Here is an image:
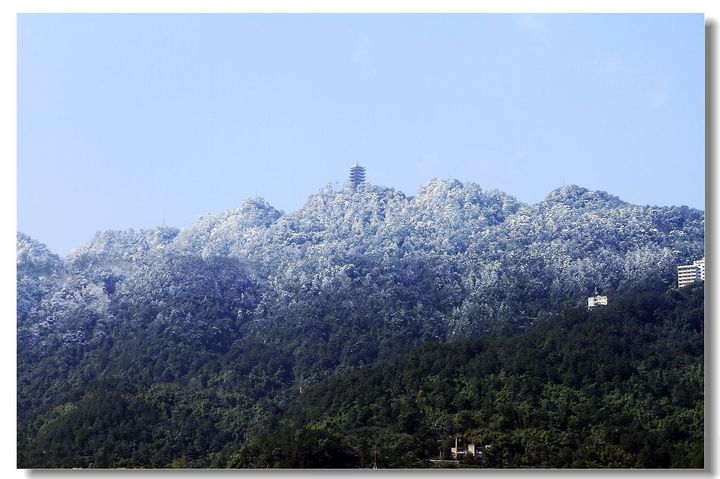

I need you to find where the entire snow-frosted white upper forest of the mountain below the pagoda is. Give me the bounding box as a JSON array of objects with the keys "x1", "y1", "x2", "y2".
[{"x1": 18, "y1": 179, "x2": 704, "y2": 350}]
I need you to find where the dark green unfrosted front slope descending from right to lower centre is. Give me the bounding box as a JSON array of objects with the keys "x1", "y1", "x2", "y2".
[{"x1": 235, "y1": 286, "x2": 704, "y2": 468}]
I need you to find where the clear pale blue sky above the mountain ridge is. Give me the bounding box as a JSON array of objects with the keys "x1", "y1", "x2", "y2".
[{"x1": 18, "y1": 14, "x2": 705, "y2": 255}]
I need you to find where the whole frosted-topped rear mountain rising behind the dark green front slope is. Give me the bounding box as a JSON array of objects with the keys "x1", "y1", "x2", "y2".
[{"x1": 17, "y1": 180, "x2": 704, "y2": 467}]
